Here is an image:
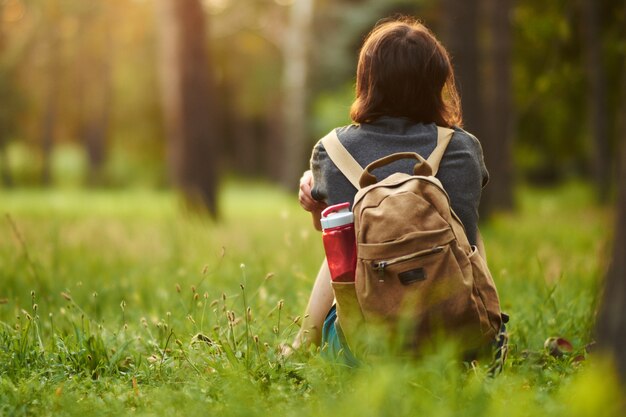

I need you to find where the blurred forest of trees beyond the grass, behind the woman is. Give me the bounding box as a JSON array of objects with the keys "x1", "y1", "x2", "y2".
[{"x1": 0, "y1": 0, "x2": 625, "y2": 205}]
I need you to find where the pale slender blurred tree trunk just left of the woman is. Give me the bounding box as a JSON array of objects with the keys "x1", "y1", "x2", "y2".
[{"x1": 281, "y1": 0, "x2": 313, "y2": 189}]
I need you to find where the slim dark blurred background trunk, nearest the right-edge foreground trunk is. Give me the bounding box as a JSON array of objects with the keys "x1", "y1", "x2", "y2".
[{"x1": 582, "y1": 0, "x2": 611, "y2": 202}]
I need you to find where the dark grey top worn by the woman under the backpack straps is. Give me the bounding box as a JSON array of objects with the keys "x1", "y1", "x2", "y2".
[{"x1": 311, "y1": 116, "x2": 489, "y2": 245}]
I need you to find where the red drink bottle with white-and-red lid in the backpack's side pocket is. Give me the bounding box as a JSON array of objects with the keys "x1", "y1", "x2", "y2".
[{"x1": 321, "y1": 203, "x2": 356, "y2": 282}]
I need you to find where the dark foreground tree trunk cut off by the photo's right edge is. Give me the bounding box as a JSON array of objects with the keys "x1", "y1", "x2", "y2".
[{"x1": 596, "y1": 52, "x2": 626, "y2": 386}]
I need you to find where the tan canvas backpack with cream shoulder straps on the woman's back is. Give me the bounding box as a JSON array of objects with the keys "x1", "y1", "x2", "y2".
[{"x1": 322, "y1": 128, "x2": 502, "y2": 352}]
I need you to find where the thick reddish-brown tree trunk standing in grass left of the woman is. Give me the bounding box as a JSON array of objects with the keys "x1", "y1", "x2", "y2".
[{"x1": 158, "y1": 0, "x2": 218, "y2": 215}]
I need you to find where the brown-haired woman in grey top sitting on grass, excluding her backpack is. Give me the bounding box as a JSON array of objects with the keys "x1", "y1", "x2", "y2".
[{"x1": 293, "y1": 18, "x2": 488, "y2": 358}]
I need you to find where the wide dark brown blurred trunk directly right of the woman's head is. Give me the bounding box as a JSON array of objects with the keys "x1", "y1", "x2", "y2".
[{"x1": 442, "y1": 0, "x2": 514, "y2": 218}]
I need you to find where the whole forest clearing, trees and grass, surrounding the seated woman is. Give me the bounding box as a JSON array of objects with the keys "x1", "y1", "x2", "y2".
[{"x1": 0, "y1": 0, "x2": 626, "y2": 415}]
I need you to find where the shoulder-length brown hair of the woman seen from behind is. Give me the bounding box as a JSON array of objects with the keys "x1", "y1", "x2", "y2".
[{"x1": 350, "y1": 18, "x2": 462, "y2": 127}]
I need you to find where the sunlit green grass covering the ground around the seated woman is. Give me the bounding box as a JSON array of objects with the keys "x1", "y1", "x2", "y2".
[{"x1": 0, "y1": 183, "x2": 624, "y2": 416}]
